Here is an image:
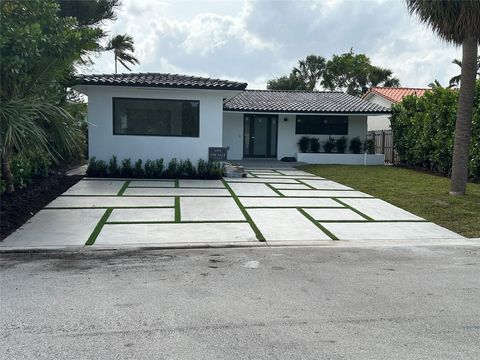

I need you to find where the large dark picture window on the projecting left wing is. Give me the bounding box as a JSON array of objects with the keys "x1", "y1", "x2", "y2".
[{"x1": 113, "y1": 98, "x2": 200, "y2": 137}]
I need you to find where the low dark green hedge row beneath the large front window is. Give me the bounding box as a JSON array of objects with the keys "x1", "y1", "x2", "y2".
[{"x1": 87, "y1": 156, "x2": 223, "y2": 179}]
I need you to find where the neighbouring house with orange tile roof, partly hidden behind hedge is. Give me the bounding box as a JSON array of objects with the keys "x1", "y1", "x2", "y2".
[{"x1": 362, "y1": 87, "x2": 428, "y2": 131}]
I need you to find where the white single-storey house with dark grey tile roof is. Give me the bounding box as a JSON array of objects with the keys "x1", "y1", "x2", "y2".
[{"x1": 74, "y1": 73, "x2": 390, "y2": 162}]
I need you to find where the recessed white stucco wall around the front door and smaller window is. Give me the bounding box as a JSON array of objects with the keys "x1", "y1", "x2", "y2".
[{"x1": 223, "y1": 112, "x2": 367, "y2": 160}]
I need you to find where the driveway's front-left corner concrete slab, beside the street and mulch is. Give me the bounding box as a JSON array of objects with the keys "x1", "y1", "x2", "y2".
[{"x1": 0, "y1": 209, "x2": 105, "y2": 247}]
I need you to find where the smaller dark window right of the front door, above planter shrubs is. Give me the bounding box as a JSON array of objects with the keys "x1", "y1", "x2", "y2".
[{"x1": 295, "y1": 115, "x2": 348, "y2": 135}]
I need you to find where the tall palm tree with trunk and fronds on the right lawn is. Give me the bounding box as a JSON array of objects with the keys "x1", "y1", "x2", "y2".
[{"x1": 406, "y1": 0, "x2": 480, "y2": 195}]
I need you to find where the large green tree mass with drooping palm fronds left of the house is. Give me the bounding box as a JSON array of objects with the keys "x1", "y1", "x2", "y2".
[{"x1": 0, "y1": 0, "x2": 109, "y2": 192}]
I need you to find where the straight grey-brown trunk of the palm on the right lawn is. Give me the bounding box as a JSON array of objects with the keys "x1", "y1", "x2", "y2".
[{"x1": 450, "y1": 38, "x2": 478, "y2": 195}]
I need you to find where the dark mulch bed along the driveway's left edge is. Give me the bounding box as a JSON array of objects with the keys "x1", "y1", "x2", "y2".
[{"x1": 0, "y1": 174, "x2": 83, "y2": 240}]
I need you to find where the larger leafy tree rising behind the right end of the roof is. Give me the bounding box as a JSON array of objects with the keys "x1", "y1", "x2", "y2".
[{"x1": 322, "y1": 49, "x2": 400, "y2": 96}]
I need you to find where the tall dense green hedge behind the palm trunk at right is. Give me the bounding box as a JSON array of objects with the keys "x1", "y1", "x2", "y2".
[{"x1": 391, "y1": 81, "x2": 480, "y2": 181}]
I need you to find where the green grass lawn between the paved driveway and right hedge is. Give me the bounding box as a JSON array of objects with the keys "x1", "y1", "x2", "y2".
[{"x1": 300, "y1": 165, "x2": 480, "y2": 237}]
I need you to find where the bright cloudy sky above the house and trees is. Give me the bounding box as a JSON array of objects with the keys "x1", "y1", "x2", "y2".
[{"x1": 82, "y1": 0, "x2": 461, "y2": 89}]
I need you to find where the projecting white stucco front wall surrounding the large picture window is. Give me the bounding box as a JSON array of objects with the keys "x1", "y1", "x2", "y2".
[{"x1": 88, "y1": 86, "x2": 230, "y2": 164}]
